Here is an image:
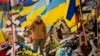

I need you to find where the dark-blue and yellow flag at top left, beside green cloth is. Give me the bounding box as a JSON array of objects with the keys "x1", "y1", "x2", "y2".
[{"x1": 17, "y1": 0, "x2": 38, "y2": 16}]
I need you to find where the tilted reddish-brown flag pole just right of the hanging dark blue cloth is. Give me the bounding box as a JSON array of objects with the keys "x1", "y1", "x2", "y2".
[{"x1": 79, "y1": 0, "x2": 87, "y2": 56}]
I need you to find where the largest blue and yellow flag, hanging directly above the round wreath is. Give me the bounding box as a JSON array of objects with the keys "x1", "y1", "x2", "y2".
[{"x1": 41, "y1": 0, "x2": 75, "y2": 27}]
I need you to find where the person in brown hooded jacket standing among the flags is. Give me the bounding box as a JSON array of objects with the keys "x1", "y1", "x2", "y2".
[{"x1": 26, "y1": 15, "x2": 47, "y2": 55}]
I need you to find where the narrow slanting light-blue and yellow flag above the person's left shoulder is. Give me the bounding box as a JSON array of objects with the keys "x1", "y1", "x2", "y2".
[{"x1": 21, "y1": 0, "x2": 46, "y2": 27}]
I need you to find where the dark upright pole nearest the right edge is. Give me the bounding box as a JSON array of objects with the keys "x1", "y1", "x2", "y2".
[{"x1": 92, "y1": 1, "x2": 98, "y2": 46}]
